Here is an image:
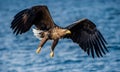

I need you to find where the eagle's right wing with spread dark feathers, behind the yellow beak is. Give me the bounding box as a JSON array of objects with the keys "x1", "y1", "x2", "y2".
[{"x1": 66, "y1": 19, "x2": 108, "y2": 58}]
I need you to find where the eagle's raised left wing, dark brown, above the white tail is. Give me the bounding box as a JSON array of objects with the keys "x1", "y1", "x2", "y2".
[{"x1": 11, "y1": 6, "x2": 54, "y2": 35}]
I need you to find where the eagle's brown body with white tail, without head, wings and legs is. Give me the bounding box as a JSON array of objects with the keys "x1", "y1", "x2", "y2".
[{"x1": 33, "y1": 27, "x2": 65, "y2": 40}]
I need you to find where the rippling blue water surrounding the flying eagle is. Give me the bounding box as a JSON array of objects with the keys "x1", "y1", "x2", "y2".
[{"x1": 0, "y1": 0, "x2": 120, "y2": 72}]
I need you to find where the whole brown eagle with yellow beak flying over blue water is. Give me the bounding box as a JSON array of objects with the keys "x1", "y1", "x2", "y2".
[{"x1": 10, "y1": 5, "x2": 108, "y2": 58}]
